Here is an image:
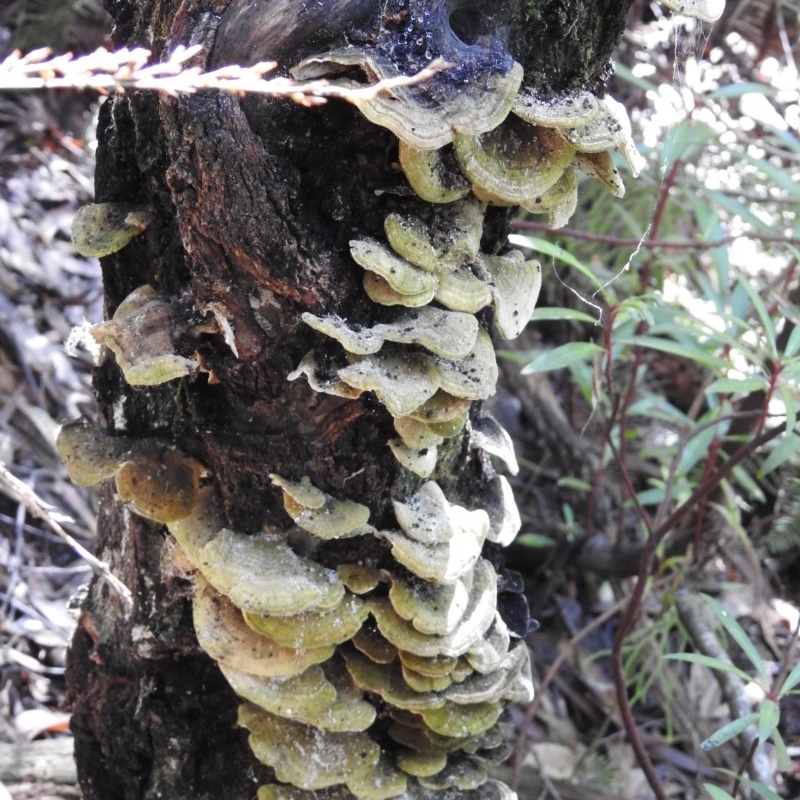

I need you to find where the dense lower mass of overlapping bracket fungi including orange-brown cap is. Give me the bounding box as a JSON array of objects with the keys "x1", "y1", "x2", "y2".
[{"x1": 57, "y1": 423, "x2": 532, "y2": 800}]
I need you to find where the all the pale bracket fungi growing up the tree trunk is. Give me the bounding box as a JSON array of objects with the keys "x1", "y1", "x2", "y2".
[{"x1": 62, "y1": 0, "x2": 720, "y2": 800}]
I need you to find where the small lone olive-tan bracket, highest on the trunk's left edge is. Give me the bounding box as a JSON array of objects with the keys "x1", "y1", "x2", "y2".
[{"x1": 72, "y1": 203, "x2": 154, "y2": 258}]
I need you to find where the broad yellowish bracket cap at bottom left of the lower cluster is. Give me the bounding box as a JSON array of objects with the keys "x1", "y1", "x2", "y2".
[{"x1": 239, "y1": 704, "x2": 380, "y2": 791}]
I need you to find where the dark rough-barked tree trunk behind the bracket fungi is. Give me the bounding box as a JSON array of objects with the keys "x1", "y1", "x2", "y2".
[{"x1": 68, "y1": 0, "x2": 629, "y2": 800}]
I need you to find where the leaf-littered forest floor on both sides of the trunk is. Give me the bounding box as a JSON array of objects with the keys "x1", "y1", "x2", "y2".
[{"x1": 0, "y1": 7, "x2": 800, "y2": 800}]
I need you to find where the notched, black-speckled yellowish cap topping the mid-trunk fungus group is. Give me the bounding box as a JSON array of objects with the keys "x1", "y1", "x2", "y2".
[{"x1": 384, "y1": 197, "x2": 483, "y2": 273}]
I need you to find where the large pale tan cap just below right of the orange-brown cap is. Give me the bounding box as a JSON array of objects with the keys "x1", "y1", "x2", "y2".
[{"x1": 198, "y1": 528, "x2": 344, "y2": 616}]
